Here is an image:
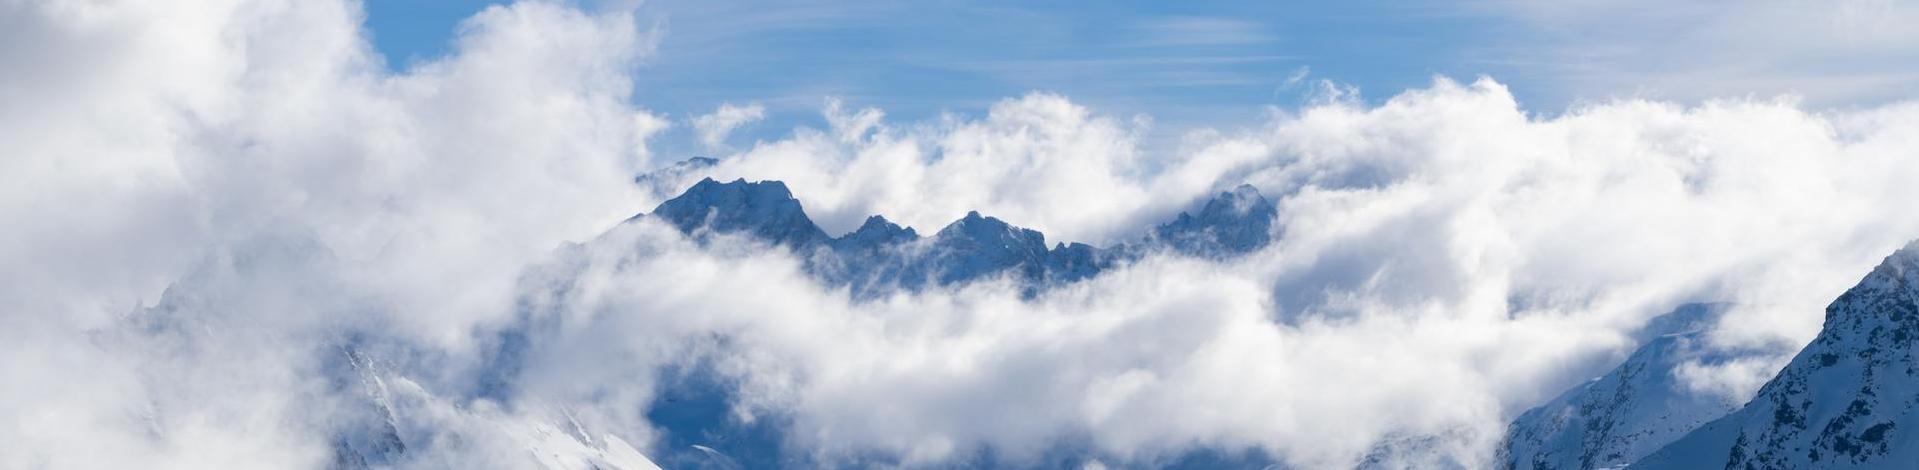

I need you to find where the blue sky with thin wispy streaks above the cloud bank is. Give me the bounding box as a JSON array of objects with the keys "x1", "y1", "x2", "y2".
[{"x1": 367, "y1": 0, "x2": 1919, "y2": 155}]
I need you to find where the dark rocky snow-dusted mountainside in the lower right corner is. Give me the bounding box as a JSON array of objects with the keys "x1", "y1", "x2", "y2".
[{"x1": 1633, "y1": 242, "x2": 1919, "y2": 468}]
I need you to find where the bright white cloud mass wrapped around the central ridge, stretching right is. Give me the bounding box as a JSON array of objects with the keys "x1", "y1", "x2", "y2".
[{"x1": 525, "y1": 81, "x2": 1919, "y2": 468}]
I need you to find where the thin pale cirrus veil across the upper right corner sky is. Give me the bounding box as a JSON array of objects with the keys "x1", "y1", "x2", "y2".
[{"x1": 1472, "y1": 0, "x2": 1919, "y2": 107}]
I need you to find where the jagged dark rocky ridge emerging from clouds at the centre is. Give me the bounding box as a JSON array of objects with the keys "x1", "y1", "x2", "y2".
[{"x1": 633, "y1": 178, "x2": 1278, "y2": 297}]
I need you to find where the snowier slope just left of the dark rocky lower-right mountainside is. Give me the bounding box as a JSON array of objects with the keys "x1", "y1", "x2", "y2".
[{"x1": 1499, "y1": 303, "x2": 1764, "y2": 470}]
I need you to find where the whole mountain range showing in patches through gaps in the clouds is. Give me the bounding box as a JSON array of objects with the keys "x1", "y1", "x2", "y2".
[{"x1": 131, "y1": 161, "x2": 1919, "y2": 468}]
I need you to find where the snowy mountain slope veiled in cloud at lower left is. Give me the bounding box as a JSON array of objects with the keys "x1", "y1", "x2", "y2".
[{"x1": 110, "y1": 232, "x2": 660, "y2": 470}]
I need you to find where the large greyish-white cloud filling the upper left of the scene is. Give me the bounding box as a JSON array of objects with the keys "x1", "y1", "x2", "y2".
[{"x1": 0, "y1": 2, "x2": 649, "y2": 468}]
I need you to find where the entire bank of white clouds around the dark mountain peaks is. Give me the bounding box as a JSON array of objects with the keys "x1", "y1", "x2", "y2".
[{"x1": 0, "y1": 2, "x2": 1919, "y2": 468}]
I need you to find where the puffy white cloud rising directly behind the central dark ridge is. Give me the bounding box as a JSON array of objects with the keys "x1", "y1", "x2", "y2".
[{"x1": 690, "y1": 94, "x2": 1166, "y2": 240}]
